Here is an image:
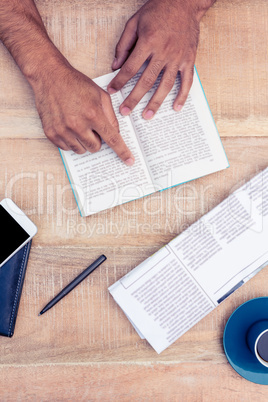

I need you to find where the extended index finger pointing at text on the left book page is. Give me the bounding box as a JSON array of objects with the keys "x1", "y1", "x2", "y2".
[{"x1": 94, "y1": 114, "x2": 135, "y2": 166}]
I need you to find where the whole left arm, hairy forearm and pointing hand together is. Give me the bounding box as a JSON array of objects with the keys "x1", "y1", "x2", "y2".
[{"x1": 0, "y1": 0, "x2": 134, "y2": 165}]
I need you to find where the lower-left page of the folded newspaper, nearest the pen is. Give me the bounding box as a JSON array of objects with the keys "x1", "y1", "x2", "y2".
[{"x1": 109, "y1": 247, "x2": 214, "y2": 353}]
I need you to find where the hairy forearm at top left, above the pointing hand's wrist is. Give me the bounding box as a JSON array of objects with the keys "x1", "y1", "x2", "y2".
[{"x1": 0, "y1": 0, "x2": 66, "y2": 83}]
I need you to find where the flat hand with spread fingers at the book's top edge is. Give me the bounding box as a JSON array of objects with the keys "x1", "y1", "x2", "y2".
[{"x1": 108, "y1": 0, "x2": 215, "y2": 119}]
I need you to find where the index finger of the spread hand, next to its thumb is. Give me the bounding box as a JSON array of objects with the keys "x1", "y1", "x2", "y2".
[{"x1": 107, "y1": 40, "x2": 151, "y2": 94}]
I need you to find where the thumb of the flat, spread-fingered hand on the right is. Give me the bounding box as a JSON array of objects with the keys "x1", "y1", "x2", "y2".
[{"x1": 112, "y1": 18, "x2": 138, "y2": 70}]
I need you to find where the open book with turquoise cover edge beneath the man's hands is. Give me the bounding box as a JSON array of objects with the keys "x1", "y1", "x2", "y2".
[{"x1": 60, "y1": 67, "x2": 229, "y2": 216}]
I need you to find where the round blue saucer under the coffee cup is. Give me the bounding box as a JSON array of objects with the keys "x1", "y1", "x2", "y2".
[{"x1": 223, "y1": 297, "x2": 268, "y2": 385}]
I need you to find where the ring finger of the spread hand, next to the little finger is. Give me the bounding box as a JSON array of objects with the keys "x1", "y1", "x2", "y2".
[{"x1": 142, "y1": 67, "x2": 178, "y2": 120}]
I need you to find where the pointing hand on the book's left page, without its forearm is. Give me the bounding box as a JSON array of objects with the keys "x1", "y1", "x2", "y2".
[{"x1": 31, "y1": 62, "x2": 134, "y2": 165}]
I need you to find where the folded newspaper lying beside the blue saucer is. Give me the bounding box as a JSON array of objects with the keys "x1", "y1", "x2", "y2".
[{"x1": 109, "y1": 168, "x2": 268, "y2": 353}]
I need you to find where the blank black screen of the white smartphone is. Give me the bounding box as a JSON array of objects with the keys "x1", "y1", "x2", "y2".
[{"x1": 0, "y1": 205, "x2": 30, "y2": 264}]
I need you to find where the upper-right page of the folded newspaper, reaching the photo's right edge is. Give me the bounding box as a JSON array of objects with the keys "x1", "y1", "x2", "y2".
[{"x1": 169, "y1": 169, "x2": 268, "y2": 304}]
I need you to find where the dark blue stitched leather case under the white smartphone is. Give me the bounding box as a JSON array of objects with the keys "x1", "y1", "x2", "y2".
[{"x1": 0, "y1": 240, "x2": 32, "y2": 338}]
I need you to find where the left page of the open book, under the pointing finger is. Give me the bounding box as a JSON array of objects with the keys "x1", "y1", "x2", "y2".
[{"x1": 61, "y1": 73, "x2": 154, "y2": 216}]
